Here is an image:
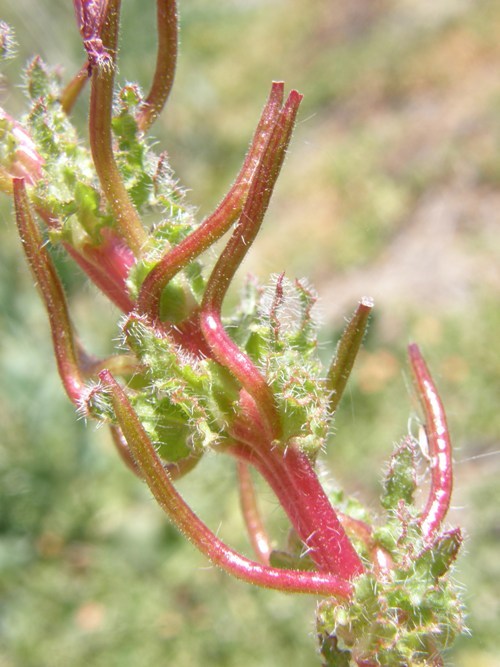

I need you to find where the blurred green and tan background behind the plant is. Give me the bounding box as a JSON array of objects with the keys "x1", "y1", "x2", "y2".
[{"x1": 0, "y1": 0, "x2": 500, "y2": 667}]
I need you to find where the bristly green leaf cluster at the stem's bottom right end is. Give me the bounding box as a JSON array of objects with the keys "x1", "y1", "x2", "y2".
[{"x1": 318, "y1": 430, "x2": 464, "y2": 667}]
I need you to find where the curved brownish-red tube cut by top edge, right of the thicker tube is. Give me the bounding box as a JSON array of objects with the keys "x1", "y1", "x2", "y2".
[{"x1": 136, "y1": 0, "x2": 178, "y2": 132}]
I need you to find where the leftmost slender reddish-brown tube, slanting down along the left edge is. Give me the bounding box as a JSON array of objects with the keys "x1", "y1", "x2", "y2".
[{"x1": 13, "y1": 178, "x2": 85, "y2": 405}]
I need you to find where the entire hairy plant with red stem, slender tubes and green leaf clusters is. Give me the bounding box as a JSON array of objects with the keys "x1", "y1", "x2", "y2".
[{"x1": 0, "y1": 0, "x2": 463, "y2": 666}]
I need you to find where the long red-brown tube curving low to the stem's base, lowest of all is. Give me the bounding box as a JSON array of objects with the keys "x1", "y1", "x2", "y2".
[{"x1": 100, "y1": 371, "x2": 352, "y2": 599}]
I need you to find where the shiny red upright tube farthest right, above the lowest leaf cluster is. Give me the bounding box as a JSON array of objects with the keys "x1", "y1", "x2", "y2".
[{"x1": 408, "y1": 343, "x2": 453, "y2": 539}]
